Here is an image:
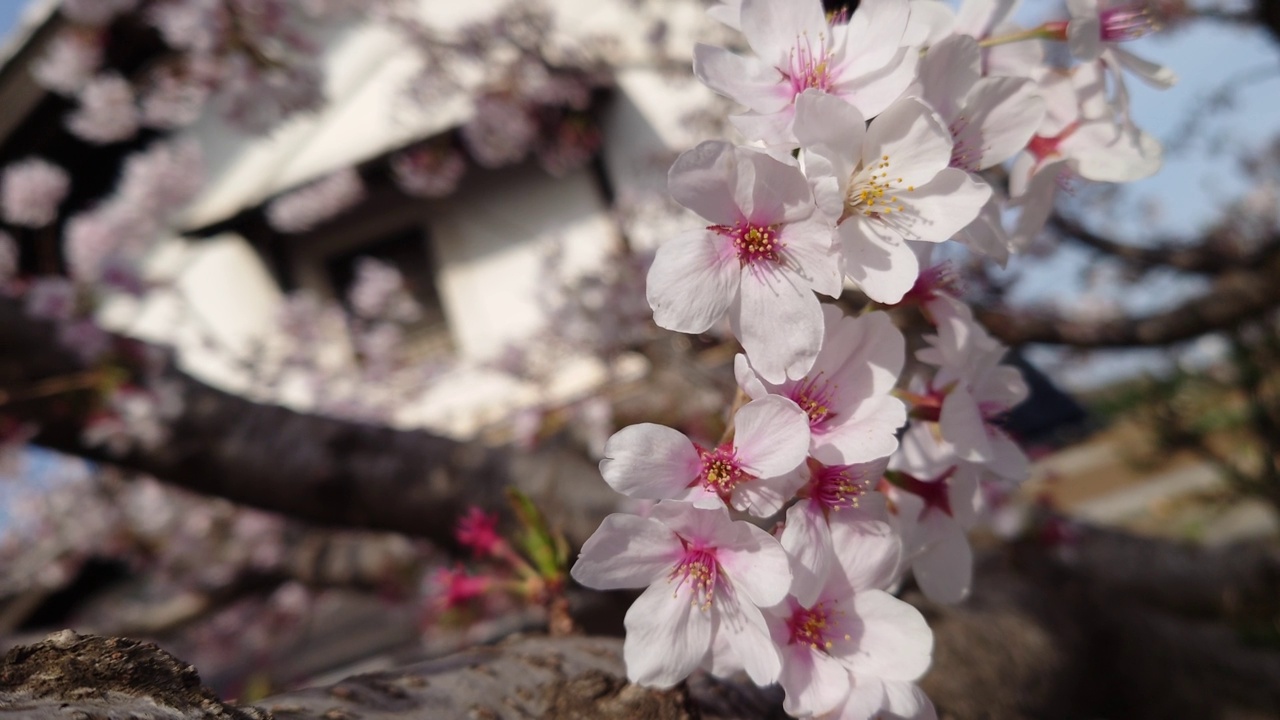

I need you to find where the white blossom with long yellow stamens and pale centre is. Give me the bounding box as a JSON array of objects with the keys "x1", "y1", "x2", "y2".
[{"x1": 795, "y1": 91, "x2": 991, "y2": 304}]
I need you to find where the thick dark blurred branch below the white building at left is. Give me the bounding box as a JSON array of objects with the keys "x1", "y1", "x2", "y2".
[{"x1": 0, "y1": 299, "x2": 616, "y2": 547}]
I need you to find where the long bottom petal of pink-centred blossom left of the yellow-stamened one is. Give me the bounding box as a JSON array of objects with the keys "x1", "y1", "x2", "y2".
[{"x1": 732, "y1": 266, "x2": 822, "y2": 383}]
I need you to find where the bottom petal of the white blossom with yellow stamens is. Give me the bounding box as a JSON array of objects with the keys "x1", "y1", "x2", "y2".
[{"x1": 836, "y1": 215, "x2": 920, "y2": 305}]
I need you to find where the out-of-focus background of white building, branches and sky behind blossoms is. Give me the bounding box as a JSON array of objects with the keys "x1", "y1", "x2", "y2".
[{"x1": 0, "y1": 0, "x2": 1280, "y2": 719}]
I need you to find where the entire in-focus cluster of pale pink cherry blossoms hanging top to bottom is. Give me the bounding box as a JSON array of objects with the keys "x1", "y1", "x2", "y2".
[{"x1": 572, "y1": 0, "x2": 1172, "y2": 719}]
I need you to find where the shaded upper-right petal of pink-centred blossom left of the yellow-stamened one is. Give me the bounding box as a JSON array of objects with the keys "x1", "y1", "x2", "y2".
[{"x1": 733, "y1": 147, "x2": 814, "y2": 222}]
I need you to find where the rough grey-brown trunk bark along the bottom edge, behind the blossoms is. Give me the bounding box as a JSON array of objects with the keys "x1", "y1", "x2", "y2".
[{"x1": 0, "y1": 529, "x2": 1280, "y2": 720}]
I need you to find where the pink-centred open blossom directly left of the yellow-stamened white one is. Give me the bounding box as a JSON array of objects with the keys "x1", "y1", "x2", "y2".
[{"x1": 646, "y1": 136, "x2": 855, "y2": 382}]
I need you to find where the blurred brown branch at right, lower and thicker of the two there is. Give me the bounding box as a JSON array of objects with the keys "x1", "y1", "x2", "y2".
[{"x1": 974, "y1": 258, "x2": 1280, "y2": 347}]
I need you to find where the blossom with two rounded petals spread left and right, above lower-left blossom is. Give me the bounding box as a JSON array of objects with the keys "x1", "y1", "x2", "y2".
[{"x1": 600, "y1": 395, "x2": 809, "y2": 518}]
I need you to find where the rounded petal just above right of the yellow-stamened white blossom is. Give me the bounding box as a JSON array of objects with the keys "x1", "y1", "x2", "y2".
[{"x1": 956, "y1": 77, "x2": 1044, "y2": 170}]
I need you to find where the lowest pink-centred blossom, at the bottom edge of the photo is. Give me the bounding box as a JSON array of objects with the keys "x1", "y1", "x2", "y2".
[{"x1": 765, "y1": 520, "x2": 933, "y2": 716}]
